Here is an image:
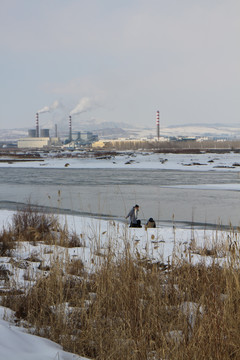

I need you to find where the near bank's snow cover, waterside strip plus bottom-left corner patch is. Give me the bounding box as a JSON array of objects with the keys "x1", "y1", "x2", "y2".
[{"x1": 0, "y1": 211, "x2": 238, "y2": 360}]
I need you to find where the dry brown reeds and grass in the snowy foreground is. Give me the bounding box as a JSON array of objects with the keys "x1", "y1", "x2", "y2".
[{"x1": 0, "y1": 209, "x2": 240, "y2": 360}]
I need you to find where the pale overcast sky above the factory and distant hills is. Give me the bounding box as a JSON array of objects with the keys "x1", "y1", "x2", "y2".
[{"x1": 0, "y1": 0, "x2": 240, "y2": 129}]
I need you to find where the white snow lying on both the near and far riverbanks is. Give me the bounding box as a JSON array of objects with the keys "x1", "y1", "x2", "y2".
[{"x1": 0, "y1": 153, "x2": 240, "y2": 360}]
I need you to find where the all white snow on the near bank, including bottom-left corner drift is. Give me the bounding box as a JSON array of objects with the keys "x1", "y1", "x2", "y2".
[{"x1": 0, "y1": 210, "x2": 234, "y2": 360}]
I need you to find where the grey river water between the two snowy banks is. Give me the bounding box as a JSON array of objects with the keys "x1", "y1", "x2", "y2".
[{"x1": 0, "y1": 167, "x2": 240, "y2": 227}]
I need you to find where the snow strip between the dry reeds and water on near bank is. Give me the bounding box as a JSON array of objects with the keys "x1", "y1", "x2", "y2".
[{"x1": 0, "y1": 210, "x2": 234, "y2": 290}]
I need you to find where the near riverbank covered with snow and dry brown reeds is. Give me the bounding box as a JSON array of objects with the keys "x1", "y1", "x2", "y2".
[{"x1": 0, "y1": 208, "x2": 240, "y2": 360}]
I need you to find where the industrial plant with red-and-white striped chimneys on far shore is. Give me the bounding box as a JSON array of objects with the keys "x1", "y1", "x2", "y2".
[{"x1": 0, "y1": 110, "x2": 240, "y2": 152}]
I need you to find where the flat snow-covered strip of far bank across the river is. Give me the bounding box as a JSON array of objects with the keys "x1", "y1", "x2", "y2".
[{"x1": 0, "y1": 152, "x2": 240, "y2": 171}]
